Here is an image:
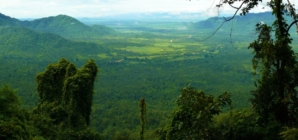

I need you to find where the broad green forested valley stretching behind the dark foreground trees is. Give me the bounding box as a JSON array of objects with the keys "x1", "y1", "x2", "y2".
[{"x1": 0, "y1": 11, "x2": 252, "y2": 137}]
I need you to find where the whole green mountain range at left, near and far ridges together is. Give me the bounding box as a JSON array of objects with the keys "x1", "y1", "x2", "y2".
[{"x1": 0, "y1": 14, "x2": 109, "y2": 60}]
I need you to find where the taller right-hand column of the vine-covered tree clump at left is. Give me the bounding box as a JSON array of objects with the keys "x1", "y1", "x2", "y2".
[{"x1": 62, "y1": 60, "x2": 98, "y2": 126}]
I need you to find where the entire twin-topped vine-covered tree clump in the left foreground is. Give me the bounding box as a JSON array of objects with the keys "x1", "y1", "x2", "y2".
[{"x1": 31, "y1": 59, "x2": 100, "y2": 139}]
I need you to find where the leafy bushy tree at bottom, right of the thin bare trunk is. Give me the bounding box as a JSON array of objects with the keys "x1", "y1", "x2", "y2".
[{"x1": 160, "y1": 86, "x2": 232, "y2": 140}]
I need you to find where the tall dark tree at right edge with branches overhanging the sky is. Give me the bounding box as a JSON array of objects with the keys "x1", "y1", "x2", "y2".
[{"x1": 217, "y1": 0, "x2": 298, "y2": 126}]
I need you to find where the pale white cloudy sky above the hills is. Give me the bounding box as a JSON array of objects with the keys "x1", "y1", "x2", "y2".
[{"x1": 0, "y1": 0, "x2": 298, "y2": 18}]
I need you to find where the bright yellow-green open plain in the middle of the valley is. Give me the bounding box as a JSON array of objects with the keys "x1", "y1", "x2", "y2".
[{"x1": 92, "y1": 22, "x2": 256, "y2": 61}]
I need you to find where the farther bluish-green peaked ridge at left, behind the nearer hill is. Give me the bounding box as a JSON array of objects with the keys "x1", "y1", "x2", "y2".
[{"x1": 0, "y1": 14, "x2": 115, "y2": 39}]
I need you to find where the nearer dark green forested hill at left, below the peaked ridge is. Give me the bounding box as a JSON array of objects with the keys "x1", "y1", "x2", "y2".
[{"x1": 0, "y1": 26, "x2": 104, "y2": 59}]
